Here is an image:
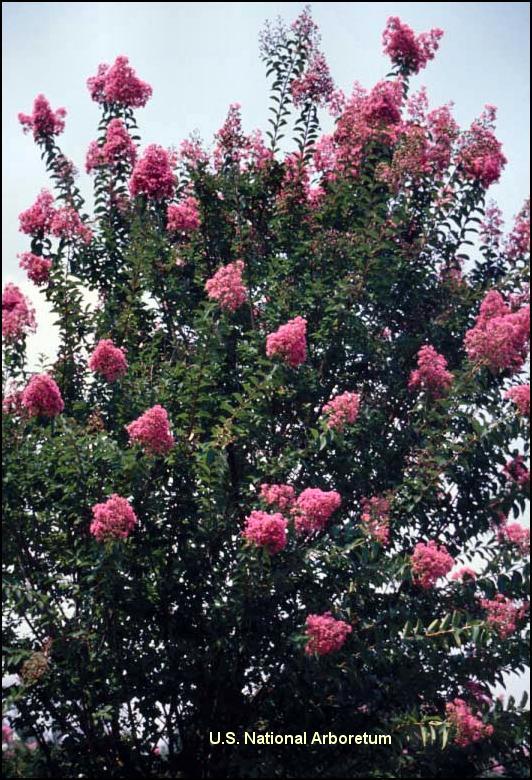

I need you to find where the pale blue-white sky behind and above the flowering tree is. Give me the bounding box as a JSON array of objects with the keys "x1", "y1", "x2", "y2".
[{"x1": 2, "y1": 2, "x2": 530, "y2": 691}]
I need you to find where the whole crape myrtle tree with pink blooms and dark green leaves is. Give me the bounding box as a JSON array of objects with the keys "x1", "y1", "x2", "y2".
[{"x1": 2, "y1": 9, "x2": 530, "y2": 777}]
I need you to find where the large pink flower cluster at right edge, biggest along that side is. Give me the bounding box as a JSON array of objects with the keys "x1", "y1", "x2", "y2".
[{"x1": 464, "y1": 290, "x2": 530, "y2": 373}]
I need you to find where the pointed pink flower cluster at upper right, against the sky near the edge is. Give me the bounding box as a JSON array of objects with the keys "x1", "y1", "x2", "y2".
[{"x1": 456, "y1": 106, "x2": 507, "y2": 189}]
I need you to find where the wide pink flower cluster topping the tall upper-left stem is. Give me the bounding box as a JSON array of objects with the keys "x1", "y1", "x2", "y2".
[{"x1": 87, "y1": 56, "x2": 152, "y2": 108}]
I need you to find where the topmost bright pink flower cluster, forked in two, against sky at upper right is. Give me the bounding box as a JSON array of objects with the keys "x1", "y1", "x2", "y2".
[{"x1": 382, "y1": 16, "x2": 443, "y2": 75}]
